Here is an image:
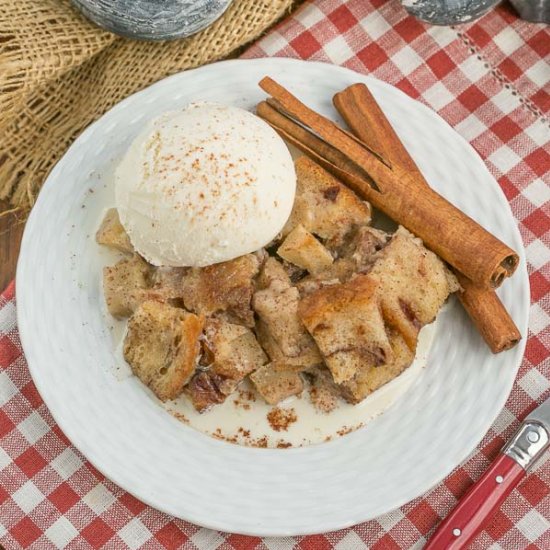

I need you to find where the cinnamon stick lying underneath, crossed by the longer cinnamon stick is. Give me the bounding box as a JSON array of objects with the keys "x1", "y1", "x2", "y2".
[{"x1": 333, "y1": 84, "x2": 521, "y2": 353}]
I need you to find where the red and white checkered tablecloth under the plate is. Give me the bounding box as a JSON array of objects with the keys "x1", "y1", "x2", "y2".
[{"x1": 0, "y1": 0, "x2": 550, "y2": 550}]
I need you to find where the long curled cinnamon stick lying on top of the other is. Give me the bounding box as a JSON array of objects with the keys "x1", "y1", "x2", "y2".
[{"x1": 260, "y1": 77, "x2": 518, "y2": 294}]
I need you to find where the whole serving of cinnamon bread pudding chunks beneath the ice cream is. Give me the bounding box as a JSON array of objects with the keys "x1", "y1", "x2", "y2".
[{"x1": 96, "y1": 157, "x2": 459, "y2": 422}]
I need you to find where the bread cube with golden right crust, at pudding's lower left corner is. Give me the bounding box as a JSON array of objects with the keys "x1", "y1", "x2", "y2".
[{"x1": 124, "y1": 300, "x2": 204, "y2": 401}]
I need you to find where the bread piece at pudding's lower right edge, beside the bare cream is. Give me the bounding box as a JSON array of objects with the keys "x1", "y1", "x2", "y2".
[{"x1": 341, "y1": 330, "x2": 414, "y2": 404}]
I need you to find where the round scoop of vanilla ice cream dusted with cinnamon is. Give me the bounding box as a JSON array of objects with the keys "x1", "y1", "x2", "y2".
[{"x1": 115, "y1": 103, "x2": 296, "y2": 267}]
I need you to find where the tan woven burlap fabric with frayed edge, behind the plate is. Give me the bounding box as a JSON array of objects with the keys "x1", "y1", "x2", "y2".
[{"x1": 0, "y1": 0, "x2": 293, "y2": 209}]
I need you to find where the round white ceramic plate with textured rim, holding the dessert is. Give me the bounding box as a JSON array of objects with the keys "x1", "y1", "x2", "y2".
[{"x1": 17, "y1": 59, "x2": 529, "y2": 536}]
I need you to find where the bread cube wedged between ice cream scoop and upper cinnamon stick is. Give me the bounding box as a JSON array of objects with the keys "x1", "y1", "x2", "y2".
[{"x1": 283, "y1": 156, "x2": 371, "y2": 246}]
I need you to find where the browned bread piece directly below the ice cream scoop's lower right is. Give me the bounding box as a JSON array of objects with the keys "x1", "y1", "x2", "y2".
[{"x1": 183, "y1": 254, "x2": 260, "y2": 327}]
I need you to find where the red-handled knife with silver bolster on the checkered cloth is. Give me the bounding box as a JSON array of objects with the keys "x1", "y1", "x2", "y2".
[{"x1": 424, "y1": 398, "x2": 550, "y2": 550}]
